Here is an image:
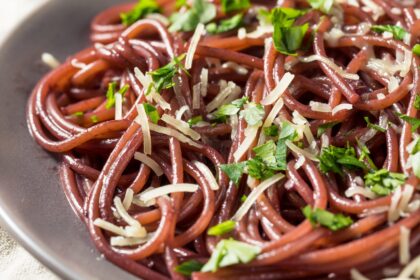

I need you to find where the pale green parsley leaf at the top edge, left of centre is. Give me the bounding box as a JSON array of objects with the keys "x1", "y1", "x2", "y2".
[{"x1": 169, "y1": 0, "x2": 216, "y2": 32}]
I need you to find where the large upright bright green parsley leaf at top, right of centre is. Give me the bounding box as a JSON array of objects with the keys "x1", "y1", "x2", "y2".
[{"x1": 271, "y1": 8, "x2": 309, "y2": 55}]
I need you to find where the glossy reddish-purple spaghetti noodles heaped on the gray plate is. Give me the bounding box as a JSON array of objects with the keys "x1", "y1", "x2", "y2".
[{"x1": 27, "y1": 0, "x2": 420, "y2": 279}]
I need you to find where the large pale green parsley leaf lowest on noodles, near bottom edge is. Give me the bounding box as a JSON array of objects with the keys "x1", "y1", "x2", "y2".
[{"x1": 201, "y1": 238, "x2": 261, "y2": 272}]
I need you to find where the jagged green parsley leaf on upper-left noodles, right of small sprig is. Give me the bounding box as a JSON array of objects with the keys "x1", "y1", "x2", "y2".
[{"x1": 147, "y1": 54, "x2": 189, "y2": 93}]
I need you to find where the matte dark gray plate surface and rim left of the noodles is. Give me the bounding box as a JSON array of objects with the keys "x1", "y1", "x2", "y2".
[{"x1": 0, "y1": 0, "x2": 135, "y2": 279}]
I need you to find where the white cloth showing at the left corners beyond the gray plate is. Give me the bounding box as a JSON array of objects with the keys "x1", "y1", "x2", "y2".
[{"x1": 0, "y1": 0, "x2": 58, "y2": 280}]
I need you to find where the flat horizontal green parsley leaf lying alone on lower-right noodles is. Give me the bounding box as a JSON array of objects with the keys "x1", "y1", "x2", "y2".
[{"x1": 302, "y1": 205, "x2": 353, "y2": 231}]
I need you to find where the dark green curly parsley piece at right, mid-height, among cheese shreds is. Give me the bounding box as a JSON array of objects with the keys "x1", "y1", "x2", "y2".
[{"x1": 319, "y1": 145, "x2": 367, "y2": 175}]
